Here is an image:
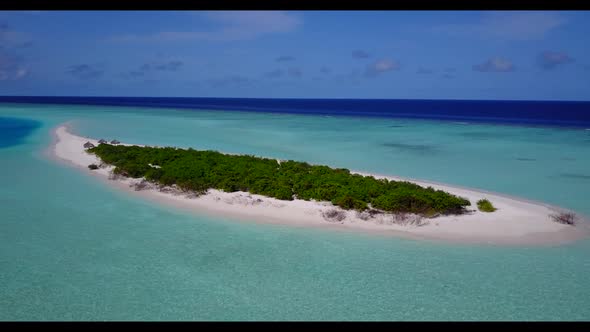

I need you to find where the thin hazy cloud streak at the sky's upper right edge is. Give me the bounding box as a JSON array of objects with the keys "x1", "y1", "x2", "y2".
[{"x1": 434, "y1": 11, "x2": 567, "y2": 40}]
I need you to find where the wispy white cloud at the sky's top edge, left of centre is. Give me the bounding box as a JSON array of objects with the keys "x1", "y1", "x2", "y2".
[{"x1": 111, "y1": 11, "x2": 303, "y2": 41}]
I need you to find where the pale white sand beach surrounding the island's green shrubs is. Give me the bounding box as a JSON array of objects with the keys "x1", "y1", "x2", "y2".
[{"x1": 51, "y1": 125, "x2": 588, "y2": 245}]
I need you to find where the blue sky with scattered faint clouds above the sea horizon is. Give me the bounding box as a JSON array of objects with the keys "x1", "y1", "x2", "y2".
[{"x1": 0, "y1": 11, "x2": 590, "y2": 100}]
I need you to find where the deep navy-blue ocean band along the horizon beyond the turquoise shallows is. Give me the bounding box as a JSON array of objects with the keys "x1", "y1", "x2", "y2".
[{"x1": 0, "y1": 96, "x2": 590, "y2": 128}]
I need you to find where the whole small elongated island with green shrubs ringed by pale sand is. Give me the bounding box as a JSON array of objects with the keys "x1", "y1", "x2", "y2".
[{"x1": 52, "y1": 125, "x2": 586, "y2": 244}]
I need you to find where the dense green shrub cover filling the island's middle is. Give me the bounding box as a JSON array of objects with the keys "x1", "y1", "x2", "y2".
[{"x1": 88, "y1": 144, "x2": 470, "y2": 216}]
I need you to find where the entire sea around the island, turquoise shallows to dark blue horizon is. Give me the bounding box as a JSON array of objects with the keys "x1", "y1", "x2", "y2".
[{"x1": 0, "y1": 97, "x2": 590, "y2": 320}]
